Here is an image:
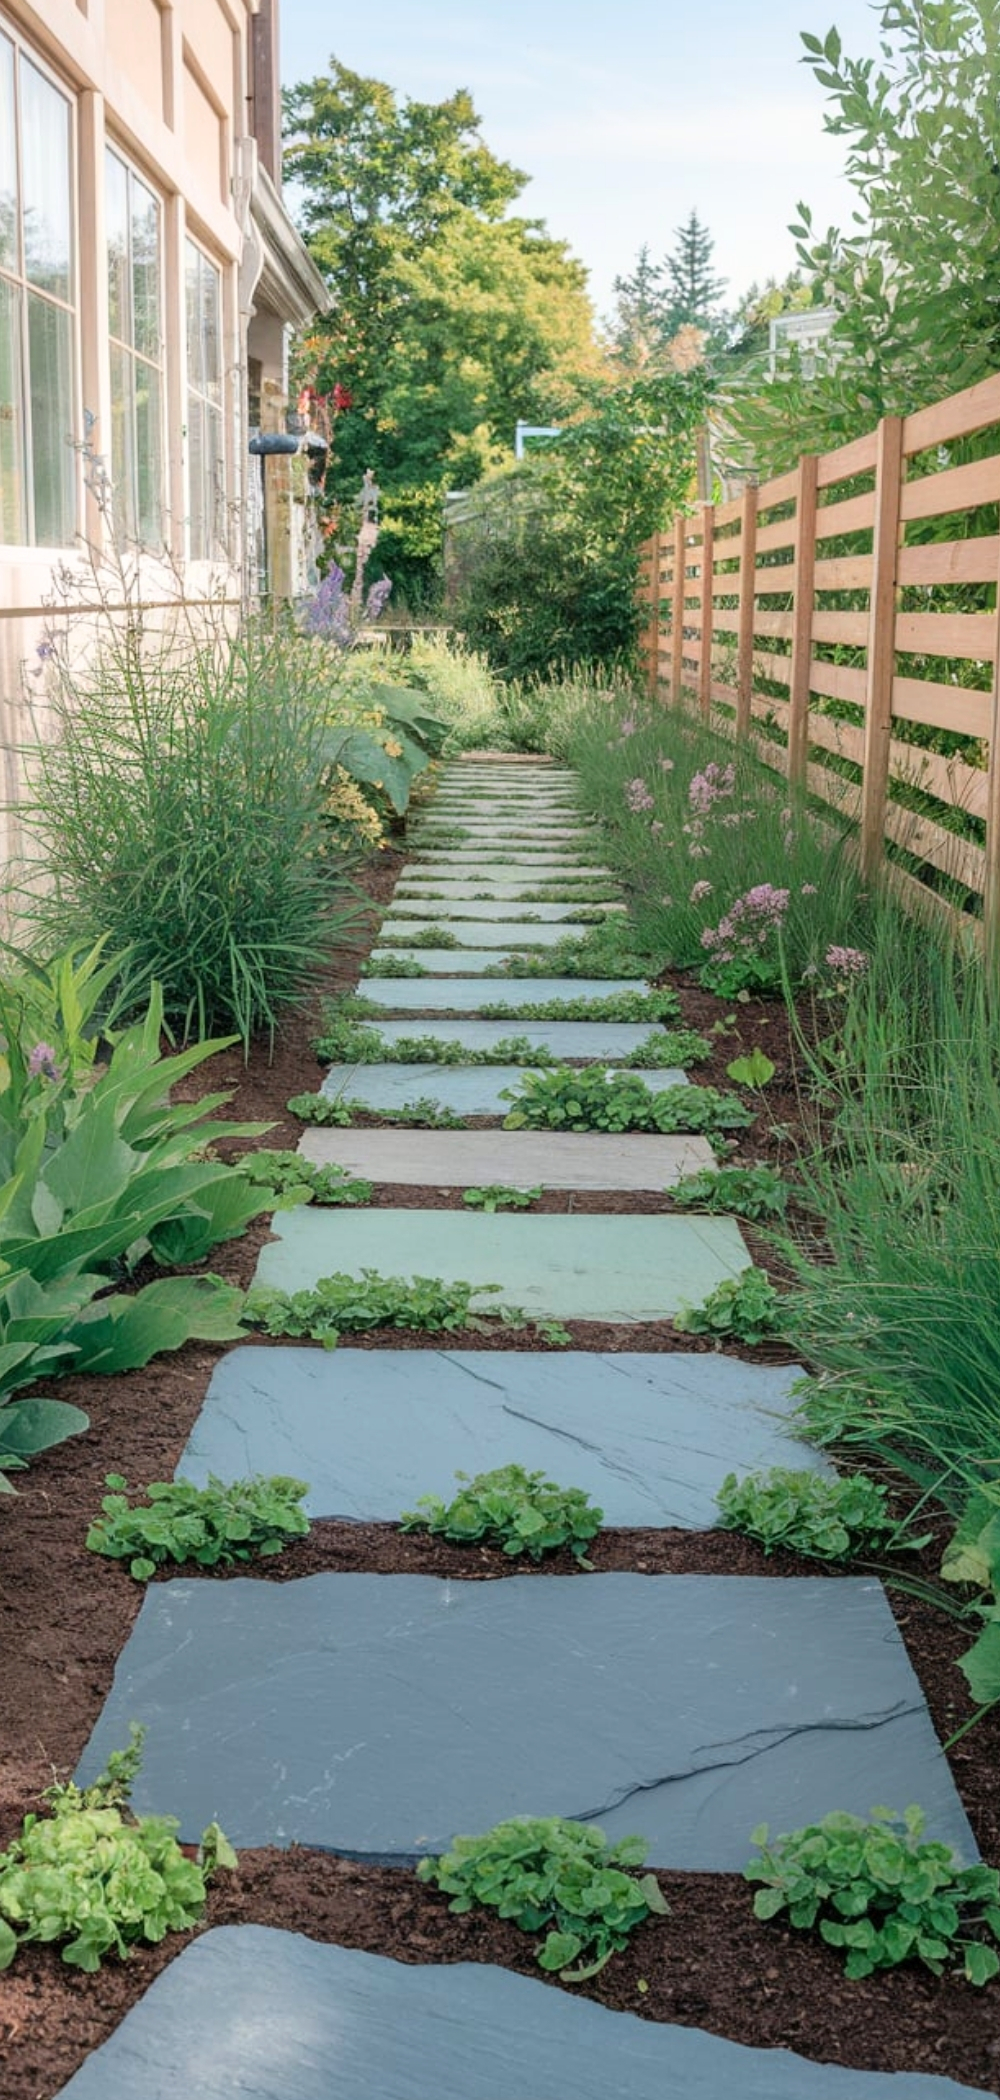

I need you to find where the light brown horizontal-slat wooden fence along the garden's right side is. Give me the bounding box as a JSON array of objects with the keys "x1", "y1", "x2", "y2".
[{"x1": 641, "y1": 374, "x2": 1000, "y2": 960}]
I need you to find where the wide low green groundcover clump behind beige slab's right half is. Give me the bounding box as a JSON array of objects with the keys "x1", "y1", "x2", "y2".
[{"x1": 504, "y1": 1065, "x2": 752, "y2": 1132}]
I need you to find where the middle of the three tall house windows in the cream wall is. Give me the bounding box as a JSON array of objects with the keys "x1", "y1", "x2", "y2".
[{"x1": 105, "y1": 149, "x2": 164, "y2": 548}]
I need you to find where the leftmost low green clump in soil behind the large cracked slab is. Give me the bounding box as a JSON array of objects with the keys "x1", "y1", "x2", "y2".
[{"x1": 86, "y1": 1472, "x2": 309, "y2": 1581}]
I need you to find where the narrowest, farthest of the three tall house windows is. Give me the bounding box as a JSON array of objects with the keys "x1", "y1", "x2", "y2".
[{"x1": 185, "y1": 242, "x2": 225, "y2": 561}]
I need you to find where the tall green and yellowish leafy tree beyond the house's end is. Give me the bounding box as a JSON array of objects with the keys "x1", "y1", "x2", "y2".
[{"x1": 286, "y1": 59, "x2": 603, "y2": 603}]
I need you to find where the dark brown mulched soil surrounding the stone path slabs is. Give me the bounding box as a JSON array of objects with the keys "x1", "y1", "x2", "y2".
[{"x1": 0, "y1": 823, "x2": 1000, "y2": 2100}]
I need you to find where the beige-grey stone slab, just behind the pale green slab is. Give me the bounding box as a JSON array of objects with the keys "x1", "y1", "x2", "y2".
[{"x1": 298, "y1": 1103, "x2": 714, "y2": 1191}]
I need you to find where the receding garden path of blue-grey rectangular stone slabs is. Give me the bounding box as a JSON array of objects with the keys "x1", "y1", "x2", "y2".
[{"x1": 65, "y1": 760, "x2": 987, "y2": 2100}]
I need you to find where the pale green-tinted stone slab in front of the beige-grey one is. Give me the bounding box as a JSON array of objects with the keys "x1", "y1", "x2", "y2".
[{"x1": 256, "y1": 1205, "x2": 750, "y2": 1323}]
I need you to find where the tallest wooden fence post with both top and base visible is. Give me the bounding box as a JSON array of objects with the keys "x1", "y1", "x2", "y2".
[{"x1": 861, "y1": 416, "x2": 903, "y2": 880}]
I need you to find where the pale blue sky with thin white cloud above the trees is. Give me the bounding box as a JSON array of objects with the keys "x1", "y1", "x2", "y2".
[{"x1": 282, "y1": 0, "x2": 878, "y2": 315}]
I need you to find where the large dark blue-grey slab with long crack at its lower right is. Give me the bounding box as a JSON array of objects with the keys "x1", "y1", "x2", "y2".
[{"x1": 76, "y1": 1573, "x2": 975, "y2": 1873}]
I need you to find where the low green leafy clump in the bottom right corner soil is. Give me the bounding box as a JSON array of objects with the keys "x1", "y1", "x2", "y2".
[{"x1": 744, "y1": 1808, "x2": 1000, "y2": 1985}]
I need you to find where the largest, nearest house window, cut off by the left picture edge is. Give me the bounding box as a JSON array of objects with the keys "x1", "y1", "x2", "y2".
[{"x1": 0, "y1": 32, "x2": 78, "y2": 546}]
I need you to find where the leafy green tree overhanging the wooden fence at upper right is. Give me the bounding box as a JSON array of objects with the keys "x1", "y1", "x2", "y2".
[{"x1": 729, "y1": 0, "x2": 1000, "y2": 473}]
